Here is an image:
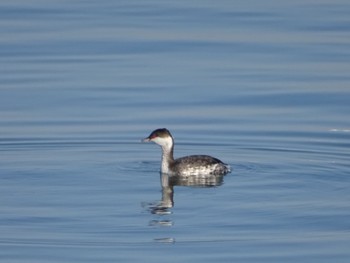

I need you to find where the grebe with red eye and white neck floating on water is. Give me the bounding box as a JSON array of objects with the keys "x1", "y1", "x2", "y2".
[{"x1": 142, "y1": 128, "x2": 231, "y2": 176}]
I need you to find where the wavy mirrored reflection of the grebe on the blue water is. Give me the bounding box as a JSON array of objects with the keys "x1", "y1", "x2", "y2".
[{"x1": 149, "y1": 173, "x2": 223, "y2": 217}]
